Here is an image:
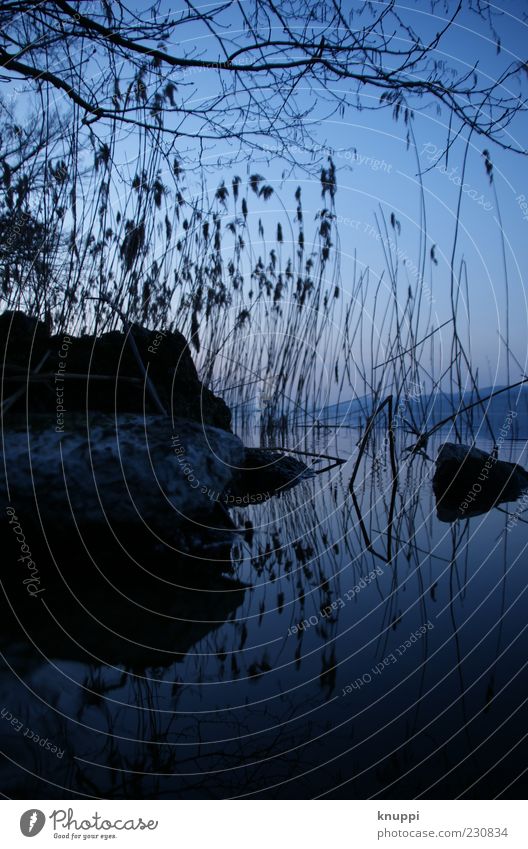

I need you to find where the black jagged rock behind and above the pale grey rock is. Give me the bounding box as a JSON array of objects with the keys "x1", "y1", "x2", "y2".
[{"x1": 0, "y1": 312, "x2": 231, "y2": 430}]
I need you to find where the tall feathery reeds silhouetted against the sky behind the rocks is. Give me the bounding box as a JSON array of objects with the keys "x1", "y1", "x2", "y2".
[{"x1": 0, "y1": 93, "x2": 511, "y2": 448}]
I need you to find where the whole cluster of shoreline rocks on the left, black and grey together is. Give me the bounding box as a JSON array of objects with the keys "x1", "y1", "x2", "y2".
[{"x1": 0, "y1": 312, "x2": 309, "y2": 551}]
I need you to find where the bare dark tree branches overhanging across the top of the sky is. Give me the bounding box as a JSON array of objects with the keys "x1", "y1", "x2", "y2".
[{"x1": 0, "y1": 0, "x2": 526, "y2": 158}]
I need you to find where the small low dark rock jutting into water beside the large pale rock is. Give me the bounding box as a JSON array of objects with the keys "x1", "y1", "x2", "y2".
[{"x1": 226, "y1": 448, "x2": 313, "y2": 504}]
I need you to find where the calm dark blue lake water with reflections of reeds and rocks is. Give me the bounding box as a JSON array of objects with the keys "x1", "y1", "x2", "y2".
[{"x1": 0, "y1": 420, "x2": 528, "y2": 799}]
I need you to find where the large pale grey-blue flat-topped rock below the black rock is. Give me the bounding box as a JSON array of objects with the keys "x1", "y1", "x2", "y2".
[{"x1": 0, "y1": 413, "x2": 244, "y2": 541}]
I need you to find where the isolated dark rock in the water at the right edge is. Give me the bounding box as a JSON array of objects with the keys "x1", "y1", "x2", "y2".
[{"x1": 433, "y1": 442, "x2": 528, "y2": 522}]
